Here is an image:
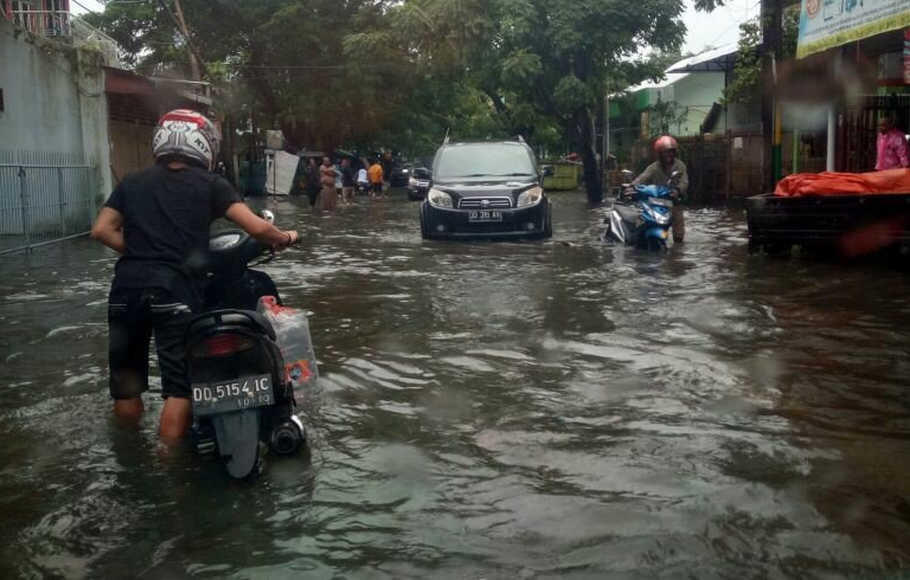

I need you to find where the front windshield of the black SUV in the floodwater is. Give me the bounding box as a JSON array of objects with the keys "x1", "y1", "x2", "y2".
[{"x1": 434, "y1": 143, "x2": 536, "y2": 179}]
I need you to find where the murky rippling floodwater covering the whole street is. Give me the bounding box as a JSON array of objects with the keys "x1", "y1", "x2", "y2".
[{"x1": 0, "y1": 194, "x2": 910, "y2": 579}]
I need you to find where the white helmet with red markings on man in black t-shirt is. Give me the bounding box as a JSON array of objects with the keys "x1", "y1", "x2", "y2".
[{"x1": 152, "y1": 109, "x2": 220, "y2": 170}]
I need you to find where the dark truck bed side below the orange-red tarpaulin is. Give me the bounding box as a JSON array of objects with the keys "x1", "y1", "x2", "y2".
[{"x1": 746, "y1": 193, "x2": 910, "y2": 256}]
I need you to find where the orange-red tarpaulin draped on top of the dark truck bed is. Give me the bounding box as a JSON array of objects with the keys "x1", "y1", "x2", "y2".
[{"x1": 774, "y1": 169, "x2": 910, "y2": 197}]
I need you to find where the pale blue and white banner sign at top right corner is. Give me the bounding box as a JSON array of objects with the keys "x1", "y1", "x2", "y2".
[{"x1": 796, "y1": 0, "x2": 910, "y2": 58}]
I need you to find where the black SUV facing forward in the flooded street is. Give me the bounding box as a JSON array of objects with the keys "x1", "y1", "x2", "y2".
[{"x1": 420, "y1": 139, "x2": 553, "y2": 238}]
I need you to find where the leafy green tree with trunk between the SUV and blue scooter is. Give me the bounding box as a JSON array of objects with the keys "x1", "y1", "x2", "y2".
[{"x1": 405, "y1": 0, "x2": 685, "y2": 203}]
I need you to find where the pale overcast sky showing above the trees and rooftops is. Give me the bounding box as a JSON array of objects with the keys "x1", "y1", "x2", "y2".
[{"x1": 72, "y1": 0, "x2": 759, "y2": 52}]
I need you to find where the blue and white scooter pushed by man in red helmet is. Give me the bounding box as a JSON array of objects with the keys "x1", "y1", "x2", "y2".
[{"x1": 602, "y1": 171, "x2": 679, "y2": 250}]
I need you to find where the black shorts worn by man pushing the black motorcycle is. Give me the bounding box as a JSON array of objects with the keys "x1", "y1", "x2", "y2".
[{"x1": 107, "y1": 288, "x2": 193, "y2": 399}]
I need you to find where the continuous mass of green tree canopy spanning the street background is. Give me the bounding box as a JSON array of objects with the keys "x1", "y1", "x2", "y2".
[{"x1": 88, "y1": 0, "x2": 722, "y2": 201}]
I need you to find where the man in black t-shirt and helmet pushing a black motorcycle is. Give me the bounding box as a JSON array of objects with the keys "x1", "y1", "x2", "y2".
[{"x1": 92, "y1": 110, "x2": 297, "y2": 444}]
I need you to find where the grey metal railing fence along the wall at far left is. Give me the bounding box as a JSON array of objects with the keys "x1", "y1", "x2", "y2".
[{"x1": 0, "y1": 151, "x2": 100, "y2": 254}]
